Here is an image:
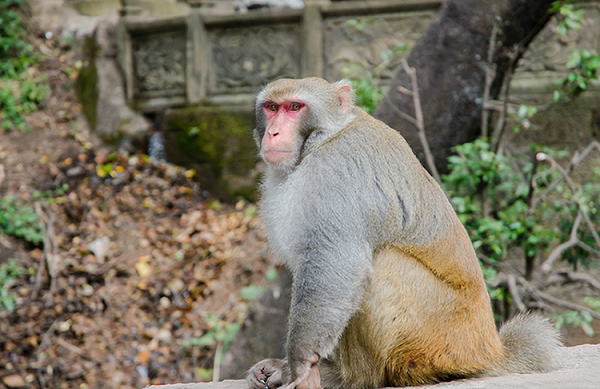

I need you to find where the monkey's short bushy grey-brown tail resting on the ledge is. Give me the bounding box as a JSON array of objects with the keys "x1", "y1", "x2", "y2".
[{"x1": 488, "y1": 313, "x2": 562, "y2": 375}]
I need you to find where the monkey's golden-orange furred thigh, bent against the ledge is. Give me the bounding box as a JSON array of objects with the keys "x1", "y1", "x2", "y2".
[{"x1": 336, "y1": 248, "x2": 501, "y2": 388}]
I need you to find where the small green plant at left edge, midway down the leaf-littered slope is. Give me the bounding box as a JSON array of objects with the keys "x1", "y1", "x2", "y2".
[{"x1": 0, "y1": 196, "x2": 44, "y2": 244}]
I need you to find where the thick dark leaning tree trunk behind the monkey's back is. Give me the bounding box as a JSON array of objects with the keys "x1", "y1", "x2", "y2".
[{"x1": 373, "y1": 0, "x2": 553, "y2": 173}]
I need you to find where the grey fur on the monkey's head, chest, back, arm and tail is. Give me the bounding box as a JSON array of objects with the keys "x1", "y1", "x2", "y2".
[{"x1": 249, "y1": 79, "x2": 559, "y2": 382}]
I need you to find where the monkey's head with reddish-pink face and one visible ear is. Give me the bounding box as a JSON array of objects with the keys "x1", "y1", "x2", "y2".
[{"x1": 254, "y1": 77, "x2": 354, "y2": 171}]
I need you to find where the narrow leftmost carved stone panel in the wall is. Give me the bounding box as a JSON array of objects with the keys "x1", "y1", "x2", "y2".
[{"x1": 132, "y1": 30, "x2": 186, "y2": 97}]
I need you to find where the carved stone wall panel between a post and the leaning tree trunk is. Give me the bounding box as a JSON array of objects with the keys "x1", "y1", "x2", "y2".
[{"x1": 323, "y1": 11, "x2": 435, "y2": 84}]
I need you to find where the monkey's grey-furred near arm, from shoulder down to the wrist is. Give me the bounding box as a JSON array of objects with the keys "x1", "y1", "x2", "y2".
[{"x1": 288, "y1": 182, "x2": 372, "y2": 380}]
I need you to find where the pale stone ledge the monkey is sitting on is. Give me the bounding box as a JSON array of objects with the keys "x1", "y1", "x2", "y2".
[{"x1": 147, "y1": 344, "x2": 600, "y2": 389}]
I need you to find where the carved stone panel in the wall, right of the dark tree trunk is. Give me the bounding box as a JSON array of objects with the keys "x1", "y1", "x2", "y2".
[{"x1": 515, "y1": 4, "x2": 600, "y2": 78}]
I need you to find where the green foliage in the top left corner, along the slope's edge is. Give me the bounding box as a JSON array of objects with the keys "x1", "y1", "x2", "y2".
[{"x1": 0, "y1": 0, "x2": 49, "y2": 130}]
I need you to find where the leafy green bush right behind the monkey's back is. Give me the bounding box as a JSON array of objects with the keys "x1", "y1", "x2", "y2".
[{"x1": 443, "y1": 139, "x2": 600, "y2": 328}]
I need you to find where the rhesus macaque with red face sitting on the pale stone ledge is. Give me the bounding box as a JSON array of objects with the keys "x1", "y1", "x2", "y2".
[{"x1": 248, "y1": 78, "x2": 561, "y2": 389}]
